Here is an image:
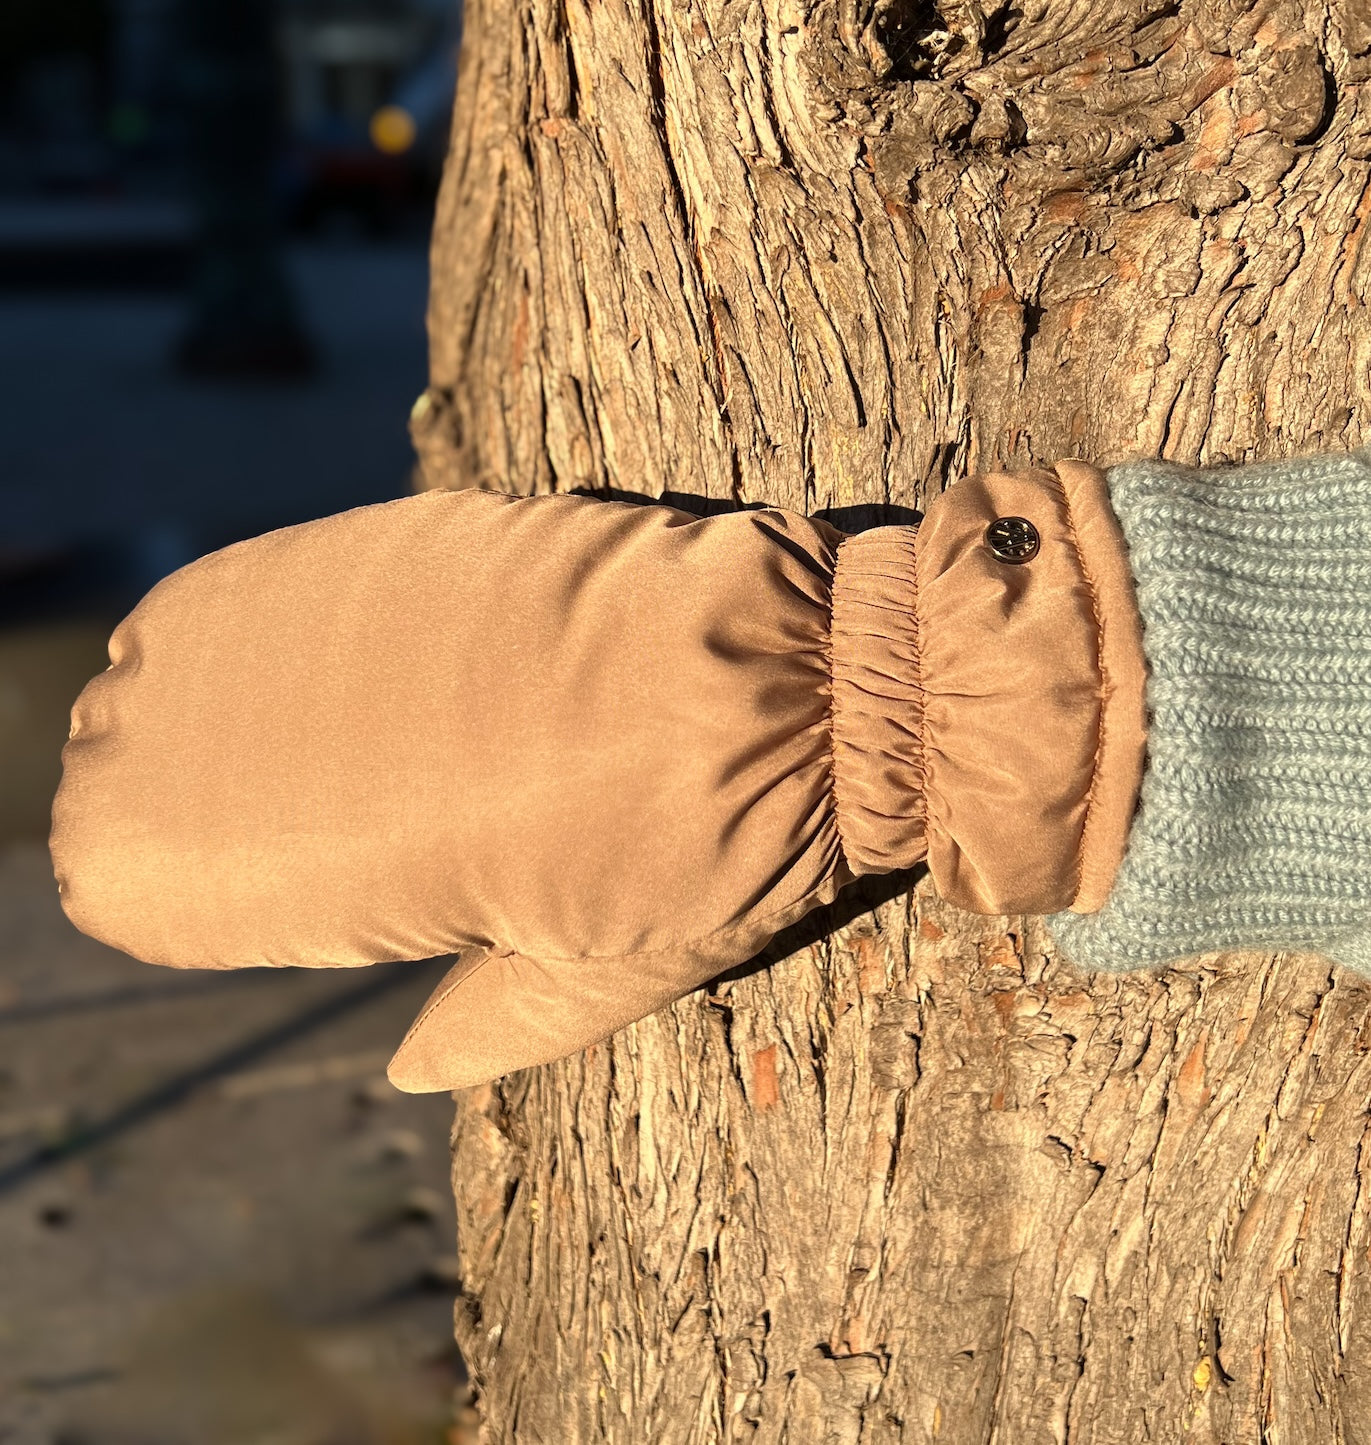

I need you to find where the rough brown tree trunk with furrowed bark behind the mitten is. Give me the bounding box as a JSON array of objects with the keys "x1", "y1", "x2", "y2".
[{"x1": 413, "y1": 0, "x2": 1371, "y2": 1445}]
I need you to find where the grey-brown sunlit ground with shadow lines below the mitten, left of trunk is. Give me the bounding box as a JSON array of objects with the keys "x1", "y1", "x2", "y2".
[{"x1": 0, "y1": 841, "x2": 461, "y2": 1445}]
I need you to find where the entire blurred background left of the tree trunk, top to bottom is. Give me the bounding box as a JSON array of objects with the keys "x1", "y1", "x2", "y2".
[{"x1": 0, "y1": 0, "x2": 470, "y2": 1445}]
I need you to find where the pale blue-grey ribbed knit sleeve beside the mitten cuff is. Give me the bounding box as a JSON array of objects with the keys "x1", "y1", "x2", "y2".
[{"x1": 1046, "y1": 448, "x2": 1371, "y2": 975}]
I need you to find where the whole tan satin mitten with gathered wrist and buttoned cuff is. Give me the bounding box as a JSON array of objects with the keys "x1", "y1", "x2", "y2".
[{"x1": 51, "y1": 462, "x2": 1144, "y2": 1091}]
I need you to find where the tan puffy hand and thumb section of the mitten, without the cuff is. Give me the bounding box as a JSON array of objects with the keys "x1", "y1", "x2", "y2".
[{"x1": 52, "y1": 491, "x2": 851, "y2": 1087}]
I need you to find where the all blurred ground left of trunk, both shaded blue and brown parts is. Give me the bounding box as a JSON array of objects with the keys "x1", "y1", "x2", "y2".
[{"x1": 0, "y1": 246, "x2": 479, "y2": 1445}]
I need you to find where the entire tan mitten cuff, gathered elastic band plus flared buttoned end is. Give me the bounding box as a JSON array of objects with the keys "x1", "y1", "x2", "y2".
[{"x1": 832, "y1": 461, "x2": 1147, "y2": 913}]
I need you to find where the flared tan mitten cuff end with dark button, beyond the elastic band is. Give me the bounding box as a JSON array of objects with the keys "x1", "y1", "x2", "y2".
[{"x1": 913, "y1": 461, "x2": 1147, "y2": 913}]
